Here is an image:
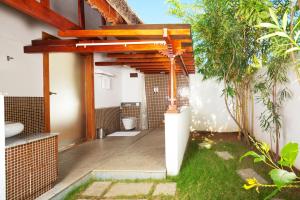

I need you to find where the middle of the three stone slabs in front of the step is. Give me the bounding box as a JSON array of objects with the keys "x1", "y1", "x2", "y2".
[{"x1": 104, "y1": 183, "x2": 153, "y2": 198}]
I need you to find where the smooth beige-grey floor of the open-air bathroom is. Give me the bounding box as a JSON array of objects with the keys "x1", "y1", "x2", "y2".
[{"x1": 37, "y1": 129, "x2": 165, "y2": 198}]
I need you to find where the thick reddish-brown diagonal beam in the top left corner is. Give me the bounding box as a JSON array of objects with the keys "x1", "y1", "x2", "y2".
[{"x1": 0, "y1": 0, "x2": 80, "y2": 30}]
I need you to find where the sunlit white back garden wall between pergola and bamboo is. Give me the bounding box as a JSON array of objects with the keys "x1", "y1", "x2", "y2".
[{"x1": 190, "y1": 74, "x2": 237, "y2": 132}]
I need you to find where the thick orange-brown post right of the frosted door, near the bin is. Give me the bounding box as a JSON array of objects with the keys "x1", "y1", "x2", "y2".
[{"x1": 84, "y1": 54, "x2": 96, "y2": 140}]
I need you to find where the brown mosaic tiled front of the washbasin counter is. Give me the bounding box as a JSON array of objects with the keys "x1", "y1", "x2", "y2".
[{"x1": 5, "y1": 136, "x2": 58, "y2": 200}]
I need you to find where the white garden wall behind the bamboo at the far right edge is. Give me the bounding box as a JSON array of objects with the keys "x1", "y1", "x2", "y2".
[{"x1": 254, "y1": 71, "x2": 300, "y2": 169}]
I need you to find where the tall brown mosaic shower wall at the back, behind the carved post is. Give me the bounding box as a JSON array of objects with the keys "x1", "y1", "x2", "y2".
[{"x1": 145, "y1": 74, "x2": 189, "y2": 128}]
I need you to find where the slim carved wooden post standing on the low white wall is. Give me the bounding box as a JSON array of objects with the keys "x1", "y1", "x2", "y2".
[{"x1": 167, "y1": 56, "x2": 178, "y2": 113}]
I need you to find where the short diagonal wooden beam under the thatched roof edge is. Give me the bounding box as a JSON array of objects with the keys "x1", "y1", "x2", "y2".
[{"x1": 87, "y1": 0, "x2": 126, "y2": 24}]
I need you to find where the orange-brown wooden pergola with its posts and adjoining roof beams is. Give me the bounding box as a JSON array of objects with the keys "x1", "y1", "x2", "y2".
[{"x1": 0, "y1": 0, "x2": 195, "y2": 140}]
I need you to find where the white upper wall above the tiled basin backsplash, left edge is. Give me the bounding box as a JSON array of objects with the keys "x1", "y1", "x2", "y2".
[{"x1": 0, "y1": 4, "x2": 56, "y2": 96}]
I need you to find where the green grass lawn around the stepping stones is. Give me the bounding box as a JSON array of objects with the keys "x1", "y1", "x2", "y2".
[{"x1": 66, "y1": 141, "x2": 300, "y2": 200}]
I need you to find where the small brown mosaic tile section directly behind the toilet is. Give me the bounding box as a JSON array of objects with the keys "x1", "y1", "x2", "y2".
[{"x1": 120, "y1": 103, "x2": 141, "y2": 130}]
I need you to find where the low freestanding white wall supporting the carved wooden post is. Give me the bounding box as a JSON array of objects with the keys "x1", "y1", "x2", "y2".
[{"x1": 165, "y1": 107, "x2": 191, "y2": 176}]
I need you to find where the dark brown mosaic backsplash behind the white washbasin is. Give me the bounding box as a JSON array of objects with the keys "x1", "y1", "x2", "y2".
[{"x1": 4, "y1": 97, "x2": 45, "y2": 135}]
